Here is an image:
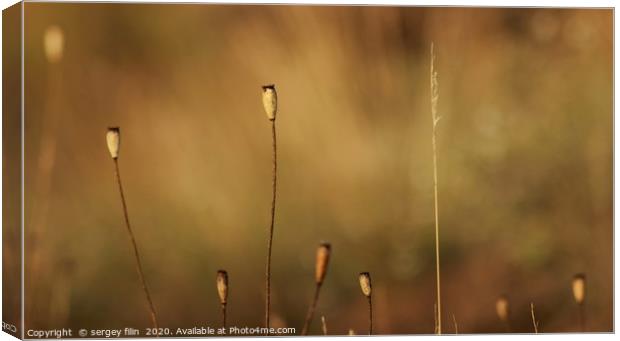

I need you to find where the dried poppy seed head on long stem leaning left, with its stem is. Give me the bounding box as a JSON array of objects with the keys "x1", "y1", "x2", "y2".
[{"x1": 106, "y1": 127, "x2": 159, "y2": 329}]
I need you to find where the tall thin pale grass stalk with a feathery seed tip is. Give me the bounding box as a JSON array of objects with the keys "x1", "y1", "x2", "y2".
[{"x1": 430, "y1": 43, "x2": 441, "y2": 334}]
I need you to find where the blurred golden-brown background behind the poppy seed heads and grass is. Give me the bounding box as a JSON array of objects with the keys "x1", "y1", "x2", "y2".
[{"x1": 12, "y1": 3, "x2": 613, "y2": 334}]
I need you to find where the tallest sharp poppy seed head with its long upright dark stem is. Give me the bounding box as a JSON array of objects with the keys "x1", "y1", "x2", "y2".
[{"x1": 262, "y1": 84, "x2": 278, "y2": 328}]
